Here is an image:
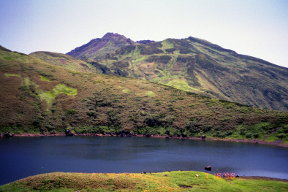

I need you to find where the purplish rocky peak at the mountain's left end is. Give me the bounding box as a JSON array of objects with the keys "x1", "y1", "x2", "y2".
[{"x1": 67, "y1": 33, "x2": 133, "y2": 61}]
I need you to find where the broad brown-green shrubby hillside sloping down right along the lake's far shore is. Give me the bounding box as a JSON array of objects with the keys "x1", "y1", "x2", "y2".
[{"x1": 0, "y1": 46, "x2": 288, "y2": 142}]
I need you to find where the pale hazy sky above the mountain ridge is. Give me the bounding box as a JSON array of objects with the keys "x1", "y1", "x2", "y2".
[{"x1": 0, "y1": 0, "x2": 288, "y2": 67}]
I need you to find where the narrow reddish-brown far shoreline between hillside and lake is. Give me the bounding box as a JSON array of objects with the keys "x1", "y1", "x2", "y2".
[{"x1": 0, "y1": 133, "x2": 288, "y2": 148}]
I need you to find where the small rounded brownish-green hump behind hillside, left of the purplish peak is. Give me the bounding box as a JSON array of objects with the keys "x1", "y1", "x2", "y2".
[{"x1": 29, "y1": 51, "x2": 98, "y2": 73}]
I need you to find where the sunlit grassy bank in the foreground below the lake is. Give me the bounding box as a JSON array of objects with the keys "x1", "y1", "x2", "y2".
[{"x1": 0, "y1": 171, "x2": 288, "y2": 192}]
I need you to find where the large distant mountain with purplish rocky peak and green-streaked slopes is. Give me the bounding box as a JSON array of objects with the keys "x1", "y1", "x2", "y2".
[{"x1": 67, "y1": 33, "x2": 288, "y2": 110}]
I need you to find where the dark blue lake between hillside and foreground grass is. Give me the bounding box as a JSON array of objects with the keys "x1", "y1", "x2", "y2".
[{"x1": 0, "y1": 137, "x2": 288, "y2": 185}]
